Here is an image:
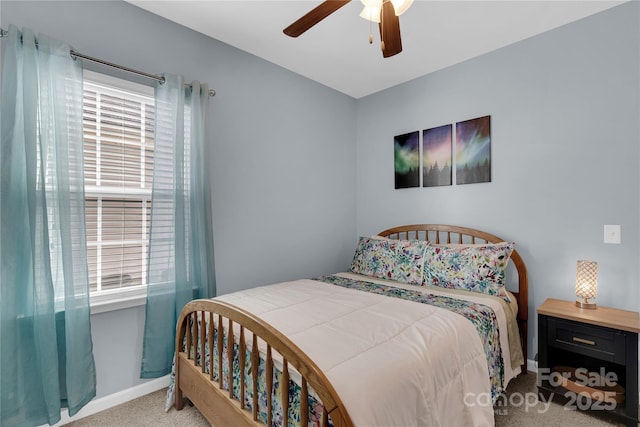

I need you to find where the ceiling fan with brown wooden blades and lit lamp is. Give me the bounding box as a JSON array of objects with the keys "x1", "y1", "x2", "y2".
[{"x1": 283, "y1": 0, "x2": 413, "y2": 58}]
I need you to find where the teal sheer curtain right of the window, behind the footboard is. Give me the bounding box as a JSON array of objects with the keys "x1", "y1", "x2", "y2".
[{"x1": 140, "y1": 75, "x2": 216, "y2": 378}]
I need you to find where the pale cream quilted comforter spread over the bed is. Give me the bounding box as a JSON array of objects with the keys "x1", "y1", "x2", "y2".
[{"x1": 216, "y1": 280, "x2": 511, "y2": 427}]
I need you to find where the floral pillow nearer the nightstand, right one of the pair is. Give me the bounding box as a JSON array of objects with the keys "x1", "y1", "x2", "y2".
[{"x1": 424, "y1": 242, "x2": 514, "y2": 302}]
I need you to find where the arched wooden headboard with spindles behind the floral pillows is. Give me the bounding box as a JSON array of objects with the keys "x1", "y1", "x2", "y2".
[{"x1": 378, "y1": 224, "x2": 529, "y2": 372}]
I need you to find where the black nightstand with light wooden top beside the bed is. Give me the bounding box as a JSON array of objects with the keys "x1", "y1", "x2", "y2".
[{"x1": 538, "y1": 298, "x2": 640, "y2": 427}]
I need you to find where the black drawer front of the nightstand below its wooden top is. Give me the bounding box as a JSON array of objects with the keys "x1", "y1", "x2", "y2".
[{"x1": 548, "y1": 318, "x2": 626, "y2": 363}]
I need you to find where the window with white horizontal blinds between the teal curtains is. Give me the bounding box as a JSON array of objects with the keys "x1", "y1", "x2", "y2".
[{"x1": 83, "y1": 71, "x2": 154, "y2": 306}]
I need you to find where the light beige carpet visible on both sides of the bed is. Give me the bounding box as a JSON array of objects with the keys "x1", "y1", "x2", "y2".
[{"x1": 68, "y1": 372, "x2": 624, "y2": 427}]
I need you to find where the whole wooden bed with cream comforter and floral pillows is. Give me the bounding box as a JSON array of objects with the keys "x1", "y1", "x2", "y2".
[{"x1": 168, "y1": 224, "x2": 528, "y2": 427}]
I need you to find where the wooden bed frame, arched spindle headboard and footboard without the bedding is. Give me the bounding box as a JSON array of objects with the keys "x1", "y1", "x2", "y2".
[{"x1": 174, "y1": 224, "x2": 528, "y2": 427}]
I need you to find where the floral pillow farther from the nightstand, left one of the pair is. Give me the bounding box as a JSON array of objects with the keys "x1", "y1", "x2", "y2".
[{"x1": 351, "y1": 237, "x2": 429, "y2": 286}]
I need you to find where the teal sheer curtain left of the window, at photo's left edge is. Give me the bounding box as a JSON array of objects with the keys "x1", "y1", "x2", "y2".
[{"x1": 0, "y1": 26, "x2": 96, "y2": 427}]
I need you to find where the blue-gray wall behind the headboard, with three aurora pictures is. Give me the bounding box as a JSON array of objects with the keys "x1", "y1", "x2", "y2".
[{"x1": 357, "y1": 2, "x2": 640, "y2": 358}]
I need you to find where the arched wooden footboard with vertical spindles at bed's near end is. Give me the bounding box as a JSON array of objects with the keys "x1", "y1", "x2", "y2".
[{"x1": 175, "y1": 300, "x2": 353, "y2": 427}]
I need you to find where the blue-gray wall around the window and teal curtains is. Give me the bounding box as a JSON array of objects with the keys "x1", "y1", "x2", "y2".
[{"x1": 0, "y1": 0, "x2": 356, "y2": 397}]
